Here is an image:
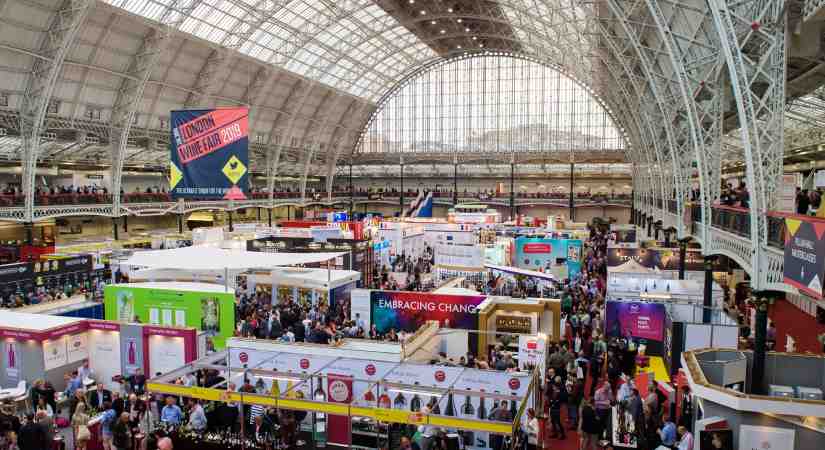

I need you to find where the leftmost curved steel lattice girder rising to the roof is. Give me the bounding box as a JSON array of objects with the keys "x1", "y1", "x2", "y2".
[{"x1": 20, "y1": 0, "x2": 92, "y2": 222}]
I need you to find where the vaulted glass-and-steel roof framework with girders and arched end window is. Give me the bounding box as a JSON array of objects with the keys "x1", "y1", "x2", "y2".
[{"x1": 0, "y1": 0, "x2": 825, "y2": 289}]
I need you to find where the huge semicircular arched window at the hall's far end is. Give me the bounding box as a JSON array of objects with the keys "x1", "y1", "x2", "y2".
[{"x1": 355, "y1": 52, "x2": 625, "y2": 154}]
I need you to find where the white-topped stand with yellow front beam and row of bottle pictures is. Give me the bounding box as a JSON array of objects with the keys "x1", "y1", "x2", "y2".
[{"x1": 147, "y1": 330, "x2": 540, "y2": 448}]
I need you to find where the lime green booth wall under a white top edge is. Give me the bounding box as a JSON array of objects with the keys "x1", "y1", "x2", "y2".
[{"x1": 104, "y1": 282, "x2": 235, "y2": 348}]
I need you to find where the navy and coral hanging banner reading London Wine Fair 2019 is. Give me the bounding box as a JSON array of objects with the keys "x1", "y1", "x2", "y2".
[{"x1": 169, "y1": 107, "x2": 249, "y2": 200}]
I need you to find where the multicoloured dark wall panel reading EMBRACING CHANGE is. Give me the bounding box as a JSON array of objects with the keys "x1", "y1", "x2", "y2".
[{"x1": 370, "y1": 291, "x2": 486, "y2": 334}]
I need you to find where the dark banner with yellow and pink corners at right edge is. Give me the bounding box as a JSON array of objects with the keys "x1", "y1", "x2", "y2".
[{"x1": 783, "y1": 216, "x2": 825, "y2": 298}]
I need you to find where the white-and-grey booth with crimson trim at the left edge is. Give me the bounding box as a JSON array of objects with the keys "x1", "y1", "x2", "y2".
[{"x1": 0, "y1": 311, "x2": 198, "y2": 392}]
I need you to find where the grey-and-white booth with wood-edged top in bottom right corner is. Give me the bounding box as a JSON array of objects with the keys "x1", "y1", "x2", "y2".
[{"x1": 682, "y1": 347, "x2": 825, "y2": 450}]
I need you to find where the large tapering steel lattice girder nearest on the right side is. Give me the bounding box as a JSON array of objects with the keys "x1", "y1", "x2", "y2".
[{"x1": 707, "y1": 0, "x2": 786, "y2": 291}]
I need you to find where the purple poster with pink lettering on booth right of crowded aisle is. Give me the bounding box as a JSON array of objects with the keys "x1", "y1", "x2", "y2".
[{"x1": 605, "y1": 301, "x2": 666, "y2": 342}]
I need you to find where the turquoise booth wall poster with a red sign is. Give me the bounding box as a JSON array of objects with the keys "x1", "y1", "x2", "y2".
[{"x1": 515, "y1": 237, "x2": 582, "y2": 277}]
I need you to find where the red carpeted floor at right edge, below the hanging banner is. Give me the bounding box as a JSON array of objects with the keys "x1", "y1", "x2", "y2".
[{"x1": 768, "y1": 299, "x2": 825, "y2": 354}]
